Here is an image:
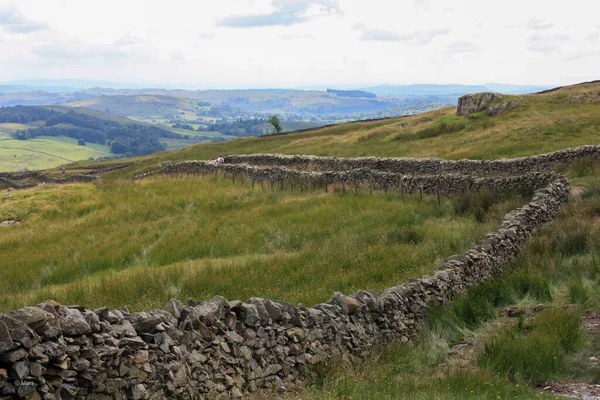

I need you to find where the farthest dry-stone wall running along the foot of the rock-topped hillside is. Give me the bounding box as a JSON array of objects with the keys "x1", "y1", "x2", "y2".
[{"x1": 225, "y1": 145, "x2": 600, "y2": 175}]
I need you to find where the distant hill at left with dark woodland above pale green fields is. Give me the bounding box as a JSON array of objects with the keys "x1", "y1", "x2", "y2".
[{"x1": 0, "y1": 106, "x2": 189, "y2": 171}]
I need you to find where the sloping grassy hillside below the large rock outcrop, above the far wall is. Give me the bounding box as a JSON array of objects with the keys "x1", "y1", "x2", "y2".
[{"x1": 105, "y1": 83, "x2": 600, "y2": 173}]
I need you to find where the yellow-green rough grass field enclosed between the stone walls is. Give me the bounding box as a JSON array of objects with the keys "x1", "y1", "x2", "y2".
[{"x1": 0, "y1": 177, "x2": 514, "y2": 310}]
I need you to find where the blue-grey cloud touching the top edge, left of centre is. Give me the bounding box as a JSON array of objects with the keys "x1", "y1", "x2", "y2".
[{"x1": 217, "y1": 0, "x2": 341, "y2": 28}]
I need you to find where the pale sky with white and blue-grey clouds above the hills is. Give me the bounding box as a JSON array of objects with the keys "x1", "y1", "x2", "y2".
[{"x1": 0, "y1": 0, "x2": 600, "y2": 89}]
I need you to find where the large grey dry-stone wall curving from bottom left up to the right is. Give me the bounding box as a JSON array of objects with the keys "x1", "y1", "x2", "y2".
[{"x1": 0, "y1": 152, "x2": 570, "y2": 399}]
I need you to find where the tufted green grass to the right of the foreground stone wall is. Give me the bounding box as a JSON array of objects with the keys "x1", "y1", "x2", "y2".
[{"x1": 288, "y1": 173, "x2": 600, "y2": 400}]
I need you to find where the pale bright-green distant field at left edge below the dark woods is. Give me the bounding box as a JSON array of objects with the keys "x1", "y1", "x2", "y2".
[{"x1": 0, "y1": 136, "x2": 112, "y2": 171}]
